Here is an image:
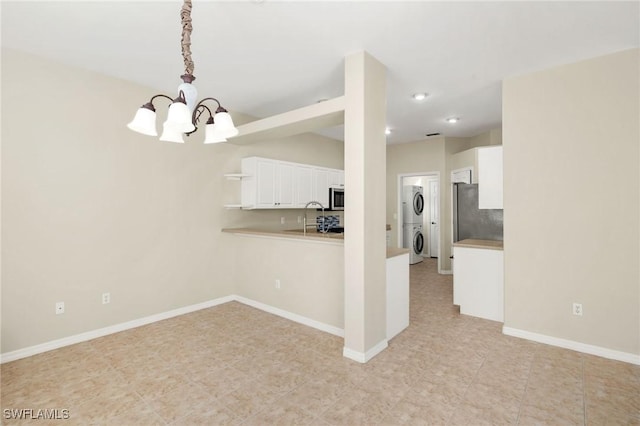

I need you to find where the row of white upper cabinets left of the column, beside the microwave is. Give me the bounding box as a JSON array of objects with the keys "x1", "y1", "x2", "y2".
[{"x1": 241, "y1": 157, "x2": 344, "y2": 209}]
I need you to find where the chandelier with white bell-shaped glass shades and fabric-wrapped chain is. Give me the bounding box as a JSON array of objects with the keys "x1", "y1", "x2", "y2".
[{"x1": 127, "y1": 0, "x2": 238, "y2": 144}]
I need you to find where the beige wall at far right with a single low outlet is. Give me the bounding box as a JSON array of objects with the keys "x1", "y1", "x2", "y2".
[{"x1": 503, "y1": 49, "x2": 640, "y2": 355}]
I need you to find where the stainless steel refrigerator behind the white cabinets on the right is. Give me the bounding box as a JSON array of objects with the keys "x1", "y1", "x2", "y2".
[{"x1": 453, "y1": 183, "x2": 503, "y2": 242}]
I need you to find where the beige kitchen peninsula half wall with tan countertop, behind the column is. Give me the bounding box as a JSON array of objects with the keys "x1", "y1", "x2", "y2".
[{"x1": 222, "y1": 228, "x2": 409, "y2": 339}]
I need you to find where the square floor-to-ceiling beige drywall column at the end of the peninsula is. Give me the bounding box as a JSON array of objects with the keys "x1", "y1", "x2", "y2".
[{"x1": 343, "y1": 52, "x2": 387, "y2": 362}]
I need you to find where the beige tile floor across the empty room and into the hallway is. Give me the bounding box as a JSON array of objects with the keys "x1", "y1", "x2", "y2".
[{"x1": 0, "y1": 259, "x2": 640, "y2": 425}]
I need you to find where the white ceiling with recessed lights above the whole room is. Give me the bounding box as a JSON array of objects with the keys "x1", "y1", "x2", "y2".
[{"x1": 0, "y1": 0, "x2": 640, "y2": 143}]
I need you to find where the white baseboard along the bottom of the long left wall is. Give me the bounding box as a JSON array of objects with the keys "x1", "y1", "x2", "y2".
[{"x1": 0, "y1": 296, "x2": 235, "y2": 364}]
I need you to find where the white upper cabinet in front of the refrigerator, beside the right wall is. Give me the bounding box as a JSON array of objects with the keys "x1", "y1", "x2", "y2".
[{"x1": 478, "y1": 146, "x2": 503, "y2": 209}]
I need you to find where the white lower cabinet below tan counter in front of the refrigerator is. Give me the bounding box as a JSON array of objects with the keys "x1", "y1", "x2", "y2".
[{"x1": 453, "y1": 246, "x2": 504, "y2": 322}]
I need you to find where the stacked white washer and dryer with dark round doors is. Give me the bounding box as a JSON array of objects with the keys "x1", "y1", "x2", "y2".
[{"x1": 402, "y1": 185, "x2": 424, "y2": 265}]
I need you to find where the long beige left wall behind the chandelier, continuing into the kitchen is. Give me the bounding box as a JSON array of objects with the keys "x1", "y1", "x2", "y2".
[{"x1": 1, "y1": 49, "x2": 344, "y2": 353}]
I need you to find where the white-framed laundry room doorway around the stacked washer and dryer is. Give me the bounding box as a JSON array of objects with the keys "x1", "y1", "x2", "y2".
[{"x1": 396, "y1": 172, "x2": 441, "y2": 271}]
